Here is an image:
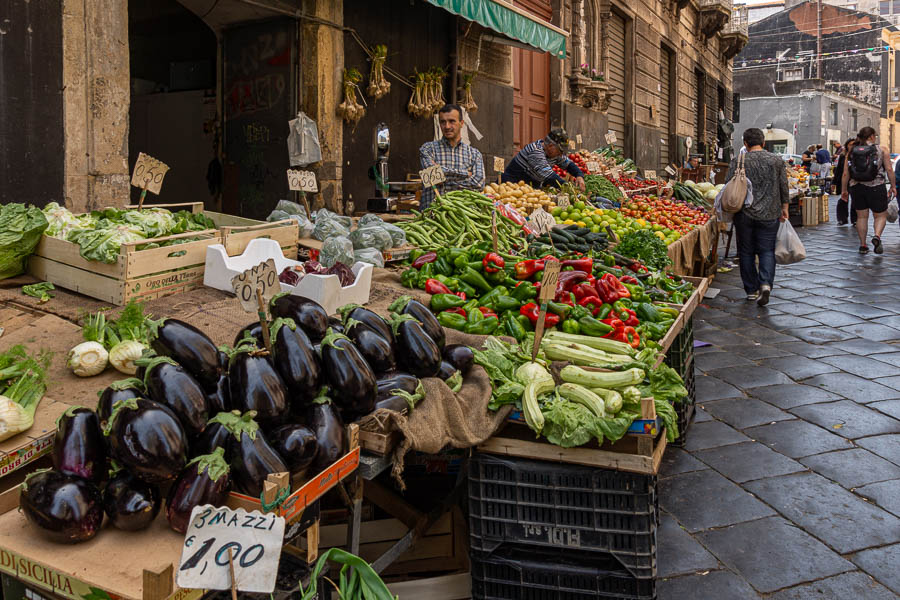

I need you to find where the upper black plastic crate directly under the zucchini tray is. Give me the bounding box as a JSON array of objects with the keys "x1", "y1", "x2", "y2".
[{"x1": 469, "y1": 453, "x2": 659, "y2": 578}]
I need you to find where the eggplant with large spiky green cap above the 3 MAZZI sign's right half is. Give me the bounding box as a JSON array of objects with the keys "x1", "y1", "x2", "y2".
[{"x1": 226, "y1": 410, "x2": 290, "y2": 498}]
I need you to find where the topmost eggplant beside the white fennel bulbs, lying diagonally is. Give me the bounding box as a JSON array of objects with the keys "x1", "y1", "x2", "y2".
[{"x1": 149, "y1": 319, "x2": 222, "y2": 392}]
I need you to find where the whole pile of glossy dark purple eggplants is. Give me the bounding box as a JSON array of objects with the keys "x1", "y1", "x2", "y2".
[{"x1": 20, "y1": 295, "x2": 472, "y2": 543}]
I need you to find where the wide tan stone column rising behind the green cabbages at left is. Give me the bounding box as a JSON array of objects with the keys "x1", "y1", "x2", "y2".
[{"x1": 62, "y1": 0, "x2": 131, "y2": 212}]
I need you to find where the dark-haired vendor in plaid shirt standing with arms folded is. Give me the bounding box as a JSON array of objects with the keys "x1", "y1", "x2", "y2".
[{"x1": 419, "y1": 104, "x2": 484, "y2": 210}]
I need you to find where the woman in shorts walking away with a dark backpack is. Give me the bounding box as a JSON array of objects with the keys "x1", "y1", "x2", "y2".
[{"x1": 841, "y1": 127, "x2": 897, "y2": 254}]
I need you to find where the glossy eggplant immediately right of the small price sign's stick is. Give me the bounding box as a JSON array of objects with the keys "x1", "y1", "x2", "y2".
[{"x1": 271, "y1": 319, "x2": 322, "y2": 410}]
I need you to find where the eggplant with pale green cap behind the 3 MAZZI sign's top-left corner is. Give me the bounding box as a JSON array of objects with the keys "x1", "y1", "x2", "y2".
[{"x1": 166, "y1": 448, "x2": 231, "y2": 533}]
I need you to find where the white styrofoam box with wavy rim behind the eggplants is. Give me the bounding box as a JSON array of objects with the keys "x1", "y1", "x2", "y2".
[{"x1": 203, "y1": 238, "x2": 375, "y2": 315}]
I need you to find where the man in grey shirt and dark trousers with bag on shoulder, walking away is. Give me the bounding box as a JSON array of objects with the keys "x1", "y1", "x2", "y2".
[{"x1": 725, "y1": 127, "x2": 790, "y2": 306}]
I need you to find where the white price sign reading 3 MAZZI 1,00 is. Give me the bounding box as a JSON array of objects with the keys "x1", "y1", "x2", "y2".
[{"x1": 175, "y1": 504, "x2": 284, "y2": 594}]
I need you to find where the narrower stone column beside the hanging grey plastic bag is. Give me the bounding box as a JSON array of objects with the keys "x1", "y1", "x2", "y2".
[{"x1": 300, "y1": 0, "x2": 345, "y2": 214}]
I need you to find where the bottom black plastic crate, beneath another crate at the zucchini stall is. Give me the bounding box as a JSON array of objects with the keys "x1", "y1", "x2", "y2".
[{"x1": 470, "y1": 544, "x2": 656, "y2": 600}]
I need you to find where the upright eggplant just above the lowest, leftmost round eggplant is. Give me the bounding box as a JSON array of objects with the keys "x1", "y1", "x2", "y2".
[{"x1": 52, "y1": 406, "x2": 107, "y2": 483}]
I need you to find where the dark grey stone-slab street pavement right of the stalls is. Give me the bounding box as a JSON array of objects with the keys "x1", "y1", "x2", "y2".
[{"x1": 659, "y1": 199, "x2": 900, "y2": 600}]
